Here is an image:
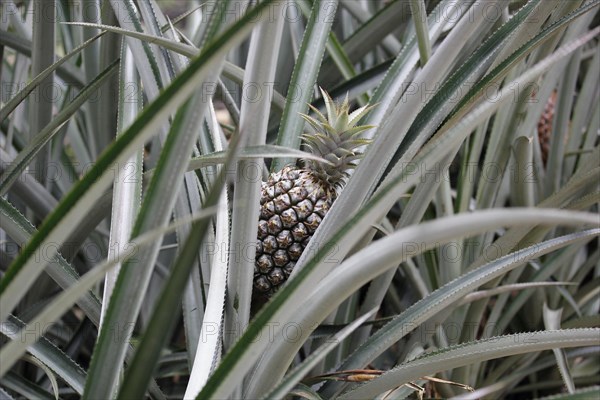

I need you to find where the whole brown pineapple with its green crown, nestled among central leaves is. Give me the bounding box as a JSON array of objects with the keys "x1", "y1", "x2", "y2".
[{"x1": 254, "y1": 89, "x2": 372, "y2": 298}]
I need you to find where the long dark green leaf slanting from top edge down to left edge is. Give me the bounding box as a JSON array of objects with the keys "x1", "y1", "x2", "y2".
[{"x1": 0, "y1": 3, "x2": 268, "y2": 360}]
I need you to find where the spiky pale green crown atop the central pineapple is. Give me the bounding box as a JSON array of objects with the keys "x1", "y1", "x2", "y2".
[{"x1": 300, "y1": 88, "x2": 375, "y2": 189}]
